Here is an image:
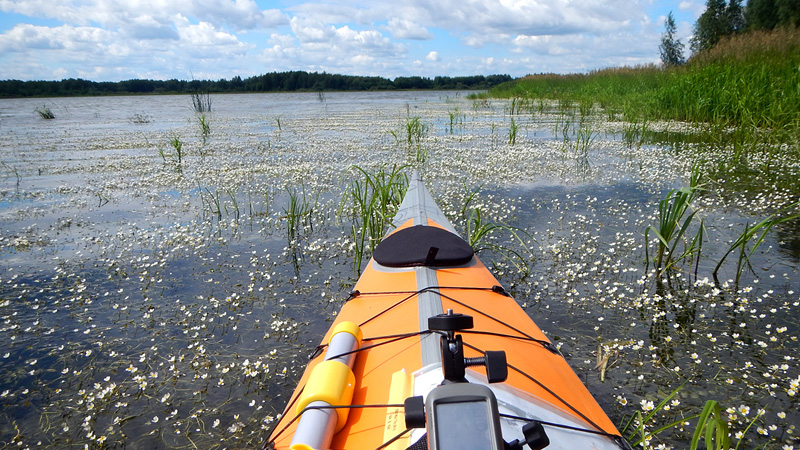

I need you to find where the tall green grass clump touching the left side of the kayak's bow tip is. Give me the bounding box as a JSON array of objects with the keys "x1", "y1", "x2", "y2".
[{"x1": 342, "y1": 165, "x2": 408, "y2": 273}]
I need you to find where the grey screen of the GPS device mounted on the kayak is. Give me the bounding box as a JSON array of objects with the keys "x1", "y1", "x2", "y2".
[{"x1": 435, "y1": 401, "x2": 494, "y2": 450}]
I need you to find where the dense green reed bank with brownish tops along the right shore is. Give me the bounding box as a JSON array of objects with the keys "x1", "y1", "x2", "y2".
[{"x1": 484, "y1": 28, "x2": 800, "y2": 152}]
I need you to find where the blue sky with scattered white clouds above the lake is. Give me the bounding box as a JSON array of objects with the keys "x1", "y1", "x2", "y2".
[{"x1": 0, "y1": 0, "x2": 705, "y2": 81}]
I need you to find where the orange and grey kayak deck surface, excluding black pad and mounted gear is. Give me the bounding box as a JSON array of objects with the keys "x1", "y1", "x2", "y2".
[{"x1": 267, "y1": 173, "x2": 628, "y2": 449}]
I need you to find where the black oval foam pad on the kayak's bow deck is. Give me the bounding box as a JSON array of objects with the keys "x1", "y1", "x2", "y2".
[{"x1": 372, "y1": 225, "x2": 475, "y2": 267}]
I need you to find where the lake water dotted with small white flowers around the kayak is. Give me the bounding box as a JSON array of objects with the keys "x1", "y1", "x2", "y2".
[{"x1": 0, "y1": 92, "x2": 800, "y2": 449}]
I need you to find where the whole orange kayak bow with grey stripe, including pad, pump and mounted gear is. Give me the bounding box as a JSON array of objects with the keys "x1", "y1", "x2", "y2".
[{"x1": 266, "y1": 172, "x2": 630, "y2": 450}]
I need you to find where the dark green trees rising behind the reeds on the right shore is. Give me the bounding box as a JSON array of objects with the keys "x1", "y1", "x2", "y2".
[{"x1": 659, "y1": 0, "x2": 800, "y2": 66}]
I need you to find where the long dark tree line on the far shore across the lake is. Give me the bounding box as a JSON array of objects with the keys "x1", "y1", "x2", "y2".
[{"x1": 0, "y1": 71, "x2": 512, "y2": 98}]
